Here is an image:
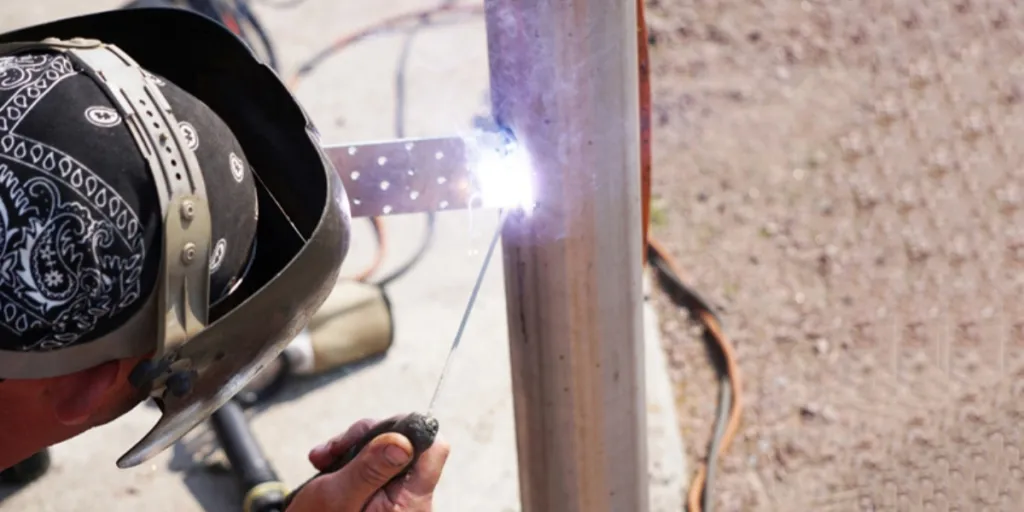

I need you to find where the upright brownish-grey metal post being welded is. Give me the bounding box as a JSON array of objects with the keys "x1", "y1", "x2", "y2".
[{"x1": 485, "y1": 0, "x2": 648, "y2": 512}]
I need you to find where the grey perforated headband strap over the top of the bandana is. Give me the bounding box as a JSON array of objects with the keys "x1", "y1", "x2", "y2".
[{"x1": 0, "y1": 38, "x2": 212, "y2": 356}]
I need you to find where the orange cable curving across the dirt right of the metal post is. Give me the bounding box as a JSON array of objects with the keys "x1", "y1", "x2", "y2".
[{"x1": 647, "y1": 239, "x2": 742, "y2": 512}]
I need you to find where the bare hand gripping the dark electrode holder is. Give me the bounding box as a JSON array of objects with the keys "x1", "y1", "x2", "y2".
[{"x1": 288, "y1": 420, "x2": 451, "y2": 512}]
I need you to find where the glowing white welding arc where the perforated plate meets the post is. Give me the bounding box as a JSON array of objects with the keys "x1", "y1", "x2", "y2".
[{"x1": 473, "y1": 138, "x2": 536, "y2": 213}]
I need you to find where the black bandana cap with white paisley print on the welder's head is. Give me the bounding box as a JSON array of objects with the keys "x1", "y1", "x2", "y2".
[{"x1": 0, "y1": 52, "x2": 256, "y2": 351}]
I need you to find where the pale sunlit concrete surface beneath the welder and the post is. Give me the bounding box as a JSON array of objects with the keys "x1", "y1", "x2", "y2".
[{"x1": 0, "y1": 0, "x2": 688, "y2": 512}]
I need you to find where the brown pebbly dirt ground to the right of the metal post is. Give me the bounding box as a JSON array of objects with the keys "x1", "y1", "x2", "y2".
[{"x1": 648, "y1": 0, "x2": 1024, "y2": 511}]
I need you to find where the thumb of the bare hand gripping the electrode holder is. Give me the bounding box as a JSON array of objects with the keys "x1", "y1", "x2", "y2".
[{"x1": 310, "y1": 433, "x2": 413, "y2": 511}]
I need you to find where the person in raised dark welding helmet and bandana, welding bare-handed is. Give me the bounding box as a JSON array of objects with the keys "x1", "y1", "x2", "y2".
[{"x1": 0, "y1": 8, "x2": 449, "y2": 512}]
